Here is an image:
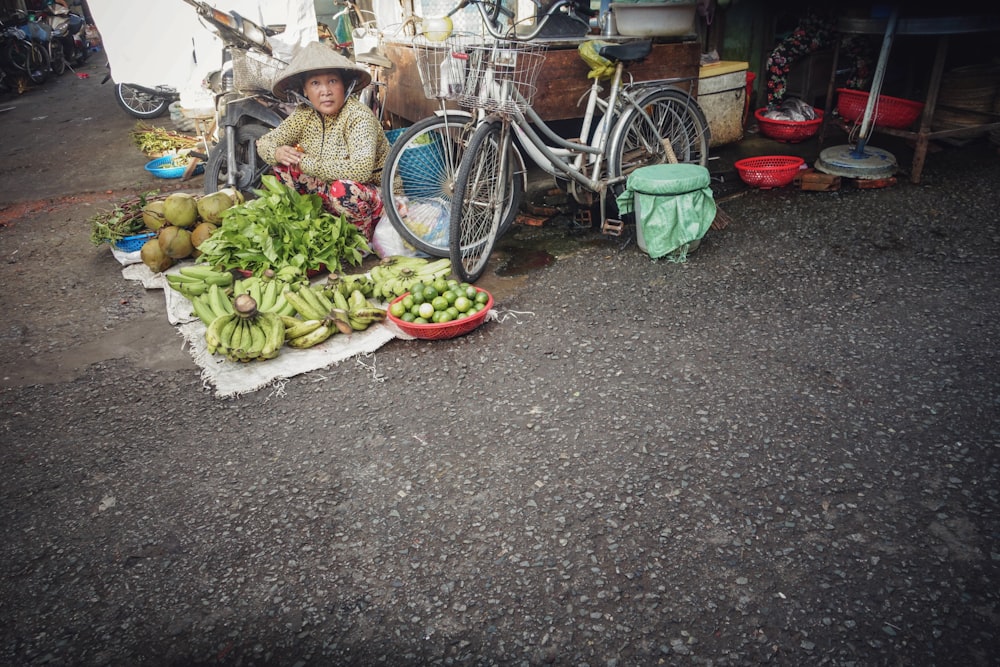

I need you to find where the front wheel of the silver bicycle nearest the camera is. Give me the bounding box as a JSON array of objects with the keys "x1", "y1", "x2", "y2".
[{"x1": 449, "y1": 119, "x2": 524, "y2": 283}]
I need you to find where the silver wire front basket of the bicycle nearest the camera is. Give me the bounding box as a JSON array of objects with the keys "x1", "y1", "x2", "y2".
[{"x1": 459, "y1": 40, "x2": 547, "y2": 113}]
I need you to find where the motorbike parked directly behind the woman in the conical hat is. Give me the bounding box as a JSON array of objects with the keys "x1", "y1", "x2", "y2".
[{"x1": 185, "y1": 0, "x2": 294, "y2": 196}]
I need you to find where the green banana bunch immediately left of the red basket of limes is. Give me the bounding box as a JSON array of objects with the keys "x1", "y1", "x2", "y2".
[{"x1": 281, "y1": 286, "x2": 385, "y2": 349}]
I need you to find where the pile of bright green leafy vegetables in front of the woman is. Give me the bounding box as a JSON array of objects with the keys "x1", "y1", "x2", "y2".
[{"x1": 198, "y1": 175, "x2": 370, "y2": 274}]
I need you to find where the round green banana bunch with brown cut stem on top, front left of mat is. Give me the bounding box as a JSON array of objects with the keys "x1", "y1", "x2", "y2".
[{"x1": 205, "y1": 294, "x2": 285, "y2": 361}]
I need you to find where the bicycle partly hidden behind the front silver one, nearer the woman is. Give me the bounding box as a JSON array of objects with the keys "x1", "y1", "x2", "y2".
[{"x1": 382, "y1": 0, "x2": 586, "y2": 257}]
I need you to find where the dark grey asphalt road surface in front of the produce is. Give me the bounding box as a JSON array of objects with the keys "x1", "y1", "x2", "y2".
[{"x1": 0, "y1": 60, "x2": 1000, "y2": 667}]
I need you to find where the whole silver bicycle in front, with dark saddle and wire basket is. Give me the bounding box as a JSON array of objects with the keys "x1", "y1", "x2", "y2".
[{"x1": 449, "y1": 40, "x2": 710, "y2": 282}]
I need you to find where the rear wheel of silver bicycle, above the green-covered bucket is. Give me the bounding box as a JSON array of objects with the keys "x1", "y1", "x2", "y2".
[{"x1": 608, "y1": 88, "x2": 709, "y2": 185}]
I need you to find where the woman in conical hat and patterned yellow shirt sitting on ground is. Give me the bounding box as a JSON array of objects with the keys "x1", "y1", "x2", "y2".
[{"x1": 257, "y1": 42, "x2": 389, "y2": 240}]
